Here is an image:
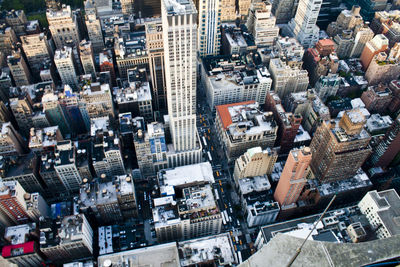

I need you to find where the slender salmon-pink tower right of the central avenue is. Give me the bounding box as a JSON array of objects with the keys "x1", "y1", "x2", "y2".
[{"x1": 274, "y1": 147, "x2": 312, "y2": 209}]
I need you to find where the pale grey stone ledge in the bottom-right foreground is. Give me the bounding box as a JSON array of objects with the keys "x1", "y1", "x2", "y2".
[{"x1": 239, "y1": 234, "x2": 400, "y2": 267}]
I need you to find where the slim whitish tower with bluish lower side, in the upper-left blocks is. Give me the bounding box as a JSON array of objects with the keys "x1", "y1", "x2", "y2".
[{"x1": 54, "y1": 46, "x2": 78, "y2": 89}]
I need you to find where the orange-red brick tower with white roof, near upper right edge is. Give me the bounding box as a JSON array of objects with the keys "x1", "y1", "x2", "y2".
[{"x1": 360, "y1": 34, "x2": 389, "y2": 70}]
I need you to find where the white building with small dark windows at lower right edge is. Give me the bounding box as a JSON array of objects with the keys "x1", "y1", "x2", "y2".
[{"x1": 358, "y1": 189, "x2": 400, "y2": 239}]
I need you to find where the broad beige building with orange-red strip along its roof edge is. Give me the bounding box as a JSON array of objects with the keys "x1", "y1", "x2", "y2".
[{"x1": 215, "y1": 101, "x2": 278, "y2": 160}]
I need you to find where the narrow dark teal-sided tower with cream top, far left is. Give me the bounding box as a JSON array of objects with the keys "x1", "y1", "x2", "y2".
[{"x1": 42, "y1": 91, "x2": 71, "y2": 136}]
